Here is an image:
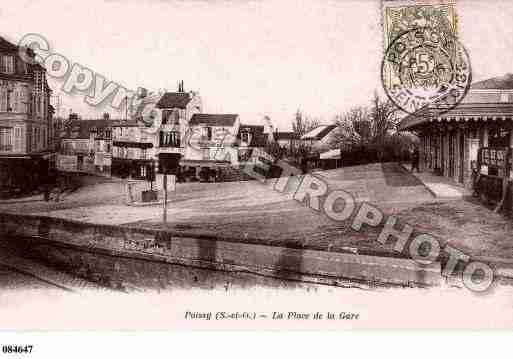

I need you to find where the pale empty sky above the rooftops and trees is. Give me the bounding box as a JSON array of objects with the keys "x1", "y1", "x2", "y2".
[{"x1": 0, "y1": 0, "x2": 513, "y2": 130}]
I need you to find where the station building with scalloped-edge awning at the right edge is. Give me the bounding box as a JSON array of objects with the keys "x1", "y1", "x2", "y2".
[{"x1": 399, "y1": 74, "x2": 513, "y2": 212}]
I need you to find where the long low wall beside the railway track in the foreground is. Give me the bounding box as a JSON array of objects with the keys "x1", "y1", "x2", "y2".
[{"x1": 0, "y1": 213, "x2": 441, "y2": 286}]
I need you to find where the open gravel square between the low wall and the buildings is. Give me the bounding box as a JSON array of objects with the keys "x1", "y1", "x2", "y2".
[{"x1": 4, "y1": 163, "x2": 513, "y2": 258}]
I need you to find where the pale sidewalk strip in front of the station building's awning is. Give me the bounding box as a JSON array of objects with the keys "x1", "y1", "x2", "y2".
[{"x1": 401, "y1": 164, "x2": 472, "y2": 200}]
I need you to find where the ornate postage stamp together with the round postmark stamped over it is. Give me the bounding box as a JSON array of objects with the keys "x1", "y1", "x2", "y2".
[{"x1": 381, "y1": 1, "x2": 472, "y2": 113}]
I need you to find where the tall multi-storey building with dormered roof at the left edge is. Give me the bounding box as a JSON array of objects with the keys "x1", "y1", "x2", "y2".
[{"x1": 0, "y1": 37, "x2": 53, "y2": 197}]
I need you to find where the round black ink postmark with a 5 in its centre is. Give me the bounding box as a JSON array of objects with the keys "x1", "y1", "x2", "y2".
[{"x1": 381, "y1": 27, "x2": 472, "y2": 113}]
